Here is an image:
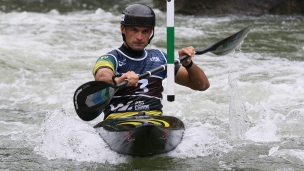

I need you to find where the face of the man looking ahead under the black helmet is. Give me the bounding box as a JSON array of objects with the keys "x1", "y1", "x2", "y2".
[{"x1": 121, "y1": 25, "x2": 153, "y2": 51}]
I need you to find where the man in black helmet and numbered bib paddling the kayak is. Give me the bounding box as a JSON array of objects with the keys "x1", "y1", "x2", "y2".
[{"x1": 93, "y1": 4, "x2": 210, "y2": 119}]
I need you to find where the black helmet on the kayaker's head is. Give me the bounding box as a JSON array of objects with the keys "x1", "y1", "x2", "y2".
[{"x1": 120, "y1": 4, "x2": 155, "y2": 27}]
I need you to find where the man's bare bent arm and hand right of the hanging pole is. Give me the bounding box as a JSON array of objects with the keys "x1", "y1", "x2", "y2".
[{"x1": 175, "y1": 46, "x2": 210, "y2": 91}]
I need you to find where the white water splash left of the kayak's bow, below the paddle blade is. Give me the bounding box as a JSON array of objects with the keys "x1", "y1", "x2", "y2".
[{"x1": 35, "y1": 108, "x2": 128, "y2": 164}]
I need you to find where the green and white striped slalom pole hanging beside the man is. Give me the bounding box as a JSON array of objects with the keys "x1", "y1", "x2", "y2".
[{"x1": 167, "y1": 0, "x2": 175, "y2": 102}]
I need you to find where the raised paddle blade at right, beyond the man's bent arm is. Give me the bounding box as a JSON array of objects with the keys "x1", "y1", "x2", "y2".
[{"x1": 196, "y1": 26, "x2": 251, "y2": 56}]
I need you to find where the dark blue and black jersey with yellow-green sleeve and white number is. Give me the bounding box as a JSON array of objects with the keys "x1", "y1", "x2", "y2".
[{"x1": 93, "y1": 49, "x2": 167, "y2": 118}]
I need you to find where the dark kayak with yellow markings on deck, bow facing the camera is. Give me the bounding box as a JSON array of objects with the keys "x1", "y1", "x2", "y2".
[{"x1": 94, "y1": 115, "x2": 185, "y2": 156}]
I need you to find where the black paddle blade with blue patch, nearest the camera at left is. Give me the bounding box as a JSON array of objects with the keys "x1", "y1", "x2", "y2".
[{"x1": 73, "y1": 81, "x2": 116, "y2": 121}]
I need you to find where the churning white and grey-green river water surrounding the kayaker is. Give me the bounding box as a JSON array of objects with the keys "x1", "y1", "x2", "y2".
[{"x1": 0, "y1": 5, "x2": 304, "y2": 171}]
